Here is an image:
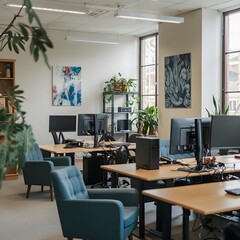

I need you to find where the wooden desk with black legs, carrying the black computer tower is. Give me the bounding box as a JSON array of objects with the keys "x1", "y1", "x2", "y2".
[{"x1": 101, "y1": 155, "x2": 240, "y2": 238}]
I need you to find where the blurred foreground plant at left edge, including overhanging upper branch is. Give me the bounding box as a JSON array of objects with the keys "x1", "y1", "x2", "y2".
[{"x1": 0, "y1": 0, "x2": 53, "y2": 187}]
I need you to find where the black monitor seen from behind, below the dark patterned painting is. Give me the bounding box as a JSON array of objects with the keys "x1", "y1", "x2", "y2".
[{"x1": 169, "y1": 118, "x2": 211, "y2": 155}]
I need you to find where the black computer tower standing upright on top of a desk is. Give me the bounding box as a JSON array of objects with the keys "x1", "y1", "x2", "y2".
[{"x1": 136, "y1": 137, "x2": 159, "y2": 170}]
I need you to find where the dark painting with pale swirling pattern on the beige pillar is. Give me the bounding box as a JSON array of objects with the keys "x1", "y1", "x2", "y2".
[{"x1": 164, "y1": 53, "x2": 191, "y2": 108}]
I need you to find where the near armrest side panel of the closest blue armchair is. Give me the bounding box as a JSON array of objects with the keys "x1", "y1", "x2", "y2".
[{"x1": 57, "y1": 199, "x2": 124, "y2": 239}]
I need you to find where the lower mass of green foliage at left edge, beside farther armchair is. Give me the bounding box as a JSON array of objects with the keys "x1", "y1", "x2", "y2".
[{"x1": 0, "y1": 86, "x2": 35, "y2": 187}]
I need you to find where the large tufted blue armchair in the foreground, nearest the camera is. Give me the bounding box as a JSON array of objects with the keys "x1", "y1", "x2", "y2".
[{"x1": 51, "y1": 166, "x2": 138, "y2": 240}]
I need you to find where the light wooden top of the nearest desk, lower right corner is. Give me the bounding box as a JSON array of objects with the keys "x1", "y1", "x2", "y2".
[{"x1": 142, "y1": 180, "x2": 240, "y2": 215}]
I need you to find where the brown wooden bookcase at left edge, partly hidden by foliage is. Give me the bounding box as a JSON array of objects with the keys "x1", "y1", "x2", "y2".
[{"x1": 0, "y1": 59, "x2": 18, "y2": 180}]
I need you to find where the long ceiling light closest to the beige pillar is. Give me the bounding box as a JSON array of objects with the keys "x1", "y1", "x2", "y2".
[{"x1": 115, "y1": 10, "x2": 184, "y2": 23}]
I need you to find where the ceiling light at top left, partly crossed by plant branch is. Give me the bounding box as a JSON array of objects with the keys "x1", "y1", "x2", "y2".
[{"x1": 5, "y1": 0, "x2": 89, "y2": 14}]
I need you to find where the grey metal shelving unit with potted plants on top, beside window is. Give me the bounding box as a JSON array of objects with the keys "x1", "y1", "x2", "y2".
[{"x1": 103, "y1": 91, "x2": 138, "y2": 140}]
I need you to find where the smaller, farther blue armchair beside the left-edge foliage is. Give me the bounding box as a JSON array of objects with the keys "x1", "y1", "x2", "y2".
[{"x1": 23, "y1": 143, "x2": 71, "y2": 201}]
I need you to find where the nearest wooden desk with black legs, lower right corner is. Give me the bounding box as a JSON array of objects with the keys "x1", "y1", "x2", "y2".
[{"x1": 142, "y1": 180, "x2": 240, "y2": 240}]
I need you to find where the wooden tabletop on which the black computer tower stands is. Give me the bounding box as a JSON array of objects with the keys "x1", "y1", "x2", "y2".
[{"x1": 101, "y1": 155, "x2": 240, "y2": 181}]
